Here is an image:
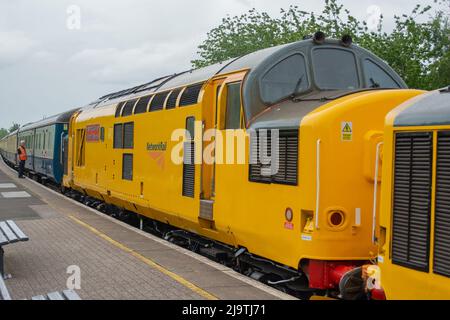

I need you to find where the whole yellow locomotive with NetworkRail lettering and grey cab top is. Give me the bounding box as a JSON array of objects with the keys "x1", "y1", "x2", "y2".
[{"x1": 59, "y1": 35, "x2": 422, "y2": 298}]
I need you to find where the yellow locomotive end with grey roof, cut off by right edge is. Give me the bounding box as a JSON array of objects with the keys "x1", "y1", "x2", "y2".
[{"x1": 378, "y1": 87, "x2": 450, "y2": 299}]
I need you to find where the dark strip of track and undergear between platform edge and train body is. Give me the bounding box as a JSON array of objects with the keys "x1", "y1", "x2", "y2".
[{"x1": 10, "y1": 162, "x2": 320, "y2": 300}]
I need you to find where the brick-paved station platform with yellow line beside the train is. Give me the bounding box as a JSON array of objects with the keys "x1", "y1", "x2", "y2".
[{"x1": 0, "y1": 159, "x2": 295, "y2": 300}]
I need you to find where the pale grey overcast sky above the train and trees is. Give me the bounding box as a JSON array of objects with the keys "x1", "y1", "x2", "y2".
[{"x1": 0, "y1": 0, "x2": 442, "y2": 128}]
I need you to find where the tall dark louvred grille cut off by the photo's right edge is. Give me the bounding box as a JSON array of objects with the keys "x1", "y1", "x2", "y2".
[{"x1": 433, "y1": 131, "x2": 450, "y2": 277}]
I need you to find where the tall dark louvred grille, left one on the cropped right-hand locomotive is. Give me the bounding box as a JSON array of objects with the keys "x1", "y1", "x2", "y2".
[{"x1": 392, "y1": 132, "x2": 433, "y2": 271}]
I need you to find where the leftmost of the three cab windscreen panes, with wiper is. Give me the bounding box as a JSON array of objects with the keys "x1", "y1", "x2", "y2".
[{"x1": 261, "y1": 54, "x2": 309, "y2": 104}]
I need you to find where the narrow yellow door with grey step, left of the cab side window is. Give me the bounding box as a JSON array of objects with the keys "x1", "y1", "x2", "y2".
[{"x1": 199, "y1": 79, "x2": 223, "y2": 221}]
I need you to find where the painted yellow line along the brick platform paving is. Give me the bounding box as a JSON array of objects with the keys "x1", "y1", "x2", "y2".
[{"x1": 69, "y1": 215, "x2": 218, "y2": 300}]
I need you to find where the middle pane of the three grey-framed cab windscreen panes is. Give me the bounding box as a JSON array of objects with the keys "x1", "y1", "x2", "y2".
[{"x1": 313, "y1": 48, "x2": 360, "y2": 90}]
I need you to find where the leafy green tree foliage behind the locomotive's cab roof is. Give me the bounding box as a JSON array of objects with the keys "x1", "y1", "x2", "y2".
[{"x1": 192, "y1": 0, "x2": 450, "y2": 90}]
